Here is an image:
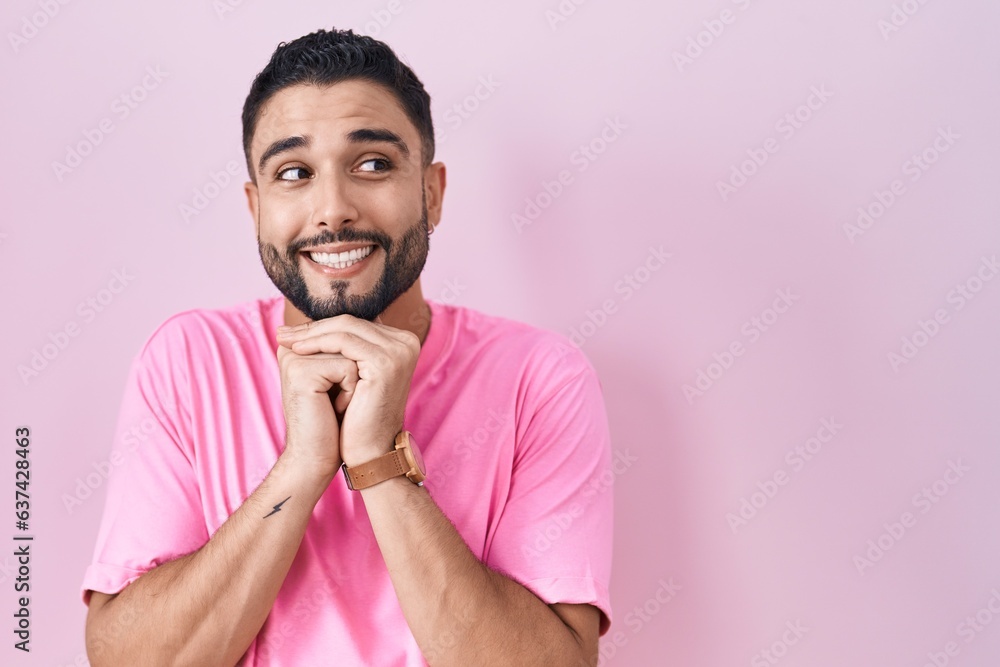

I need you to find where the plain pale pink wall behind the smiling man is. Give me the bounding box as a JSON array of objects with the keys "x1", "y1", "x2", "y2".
[{"x1": 0, "y1": 0, "x2": 1000, "y2": 667}]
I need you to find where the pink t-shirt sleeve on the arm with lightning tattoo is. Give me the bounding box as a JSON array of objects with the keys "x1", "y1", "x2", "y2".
[{"x1": 81, "y1": 319, "x2": 209, "y2": 605}]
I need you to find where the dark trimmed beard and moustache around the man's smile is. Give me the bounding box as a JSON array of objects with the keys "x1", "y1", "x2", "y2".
[{"x1": 257, "y1": 192, "x2": 430, "y2": 321}]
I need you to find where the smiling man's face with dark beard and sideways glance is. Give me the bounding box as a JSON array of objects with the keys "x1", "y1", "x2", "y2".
[{"x1": 247, "y1": 80, "x2": 429, "y2": 320}]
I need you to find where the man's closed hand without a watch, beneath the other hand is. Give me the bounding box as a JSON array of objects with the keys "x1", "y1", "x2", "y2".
[{"x1": 277, "y1": 345, "x2": 358, "y2": 483}]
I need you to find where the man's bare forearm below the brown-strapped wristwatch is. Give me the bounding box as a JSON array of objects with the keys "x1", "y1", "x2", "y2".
[{"x1": 360, "y1": 477, "x2": 587, "y2": 667}]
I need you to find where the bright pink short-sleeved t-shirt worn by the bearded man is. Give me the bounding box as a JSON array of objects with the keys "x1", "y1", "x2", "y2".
[{"x1": 81, "y1": 295, "x2": 614, "y2": 667}]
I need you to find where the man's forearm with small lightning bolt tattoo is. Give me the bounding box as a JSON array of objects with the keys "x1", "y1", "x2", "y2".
[{"x1": 87, "y1": 453, "x2": 329, "y2": 667}]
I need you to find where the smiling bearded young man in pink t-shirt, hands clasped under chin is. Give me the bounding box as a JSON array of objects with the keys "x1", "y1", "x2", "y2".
[{"x1": 82, "y1": 30, "x2": 613, "y2": 667}]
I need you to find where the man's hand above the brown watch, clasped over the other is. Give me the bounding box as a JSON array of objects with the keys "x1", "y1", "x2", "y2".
[{"x1": 278, "y1": 315, "x2": 420, "y2": 466}]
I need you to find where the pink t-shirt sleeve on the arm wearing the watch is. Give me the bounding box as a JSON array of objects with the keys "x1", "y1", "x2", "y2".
[{"x1": 484, "y1": 343, "x2": 614, "y2": 635}]
